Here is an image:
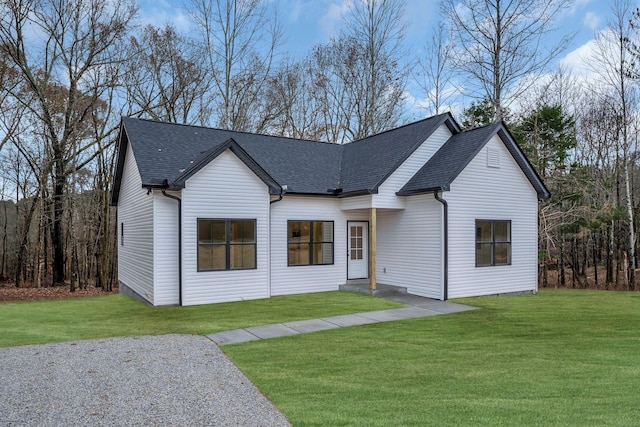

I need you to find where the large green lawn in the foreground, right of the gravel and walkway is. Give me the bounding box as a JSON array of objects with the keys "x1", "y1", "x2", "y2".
[{"x1": 222, "y1": 290, "x2": 640, "y2": 426}]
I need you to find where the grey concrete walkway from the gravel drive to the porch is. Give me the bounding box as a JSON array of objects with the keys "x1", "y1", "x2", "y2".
[{"x1": 207, "y1": 292, "x2": 476, "y2": 345}]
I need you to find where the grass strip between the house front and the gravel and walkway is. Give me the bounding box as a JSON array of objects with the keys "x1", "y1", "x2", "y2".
[{"x1": 0, "y1": 292, "x2": 401, "y2": 347}]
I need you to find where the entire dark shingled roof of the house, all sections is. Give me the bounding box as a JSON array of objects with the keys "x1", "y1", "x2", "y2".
[{"x1": 111, "y1": 113, "x2": 548, "y2": 204}]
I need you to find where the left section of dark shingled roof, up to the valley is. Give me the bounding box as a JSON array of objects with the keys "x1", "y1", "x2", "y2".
[{"x1": 112, "y1": 117, "x2": 342, "y2": 203}]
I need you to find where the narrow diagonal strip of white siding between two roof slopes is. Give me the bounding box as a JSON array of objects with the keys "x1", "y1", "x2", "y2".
[{"x1": 372, "y1": 124, "x2": 451, "y2": 209}]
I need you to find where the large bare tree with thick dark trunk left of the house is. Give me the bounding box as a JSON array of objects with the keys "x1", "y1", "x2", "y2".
[{"x1": 0, "y1": 0, "x2": 136, "y2": 283}]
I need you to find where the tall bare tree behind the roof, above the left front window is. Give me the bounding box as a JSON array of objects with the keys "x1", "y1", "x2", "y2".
[{"x1": 191, "y1": 0, "x2": 282, "y2": 131}]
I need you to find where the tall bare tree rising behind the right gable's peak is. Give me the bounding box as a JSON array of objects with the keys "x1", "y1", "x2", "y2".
[{"x1": 440, "y1": 0, "x2": 572, "y2": 120}]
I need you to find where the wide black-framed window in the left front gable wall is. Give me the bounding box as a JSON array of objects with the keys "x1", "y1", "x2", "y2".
[{"x1": 198, "y1": 219, "x2": 256, "y2": 271}]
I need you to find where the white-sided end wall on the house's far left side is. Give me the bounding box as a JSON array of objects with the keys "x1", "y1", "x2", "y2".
[{"x1": 118, "y1": 145, "x2": 154, "y2": 304}]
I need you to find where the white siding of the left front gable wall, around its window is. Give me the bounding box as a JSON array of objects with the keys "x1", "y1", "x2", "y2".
[{"x1": 182, "y1": 150, "x2": 269, "y2": 305}]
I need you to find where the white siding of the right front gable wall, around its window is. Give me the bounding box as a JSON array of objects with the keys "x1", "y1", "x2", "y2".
[{"x1": 443, "y1": 136, "x2": 538, "y2": 298}]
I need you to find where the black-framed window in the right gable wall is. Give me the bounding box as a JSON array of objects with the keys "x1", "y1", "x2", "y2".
[{"x1": 476, "y1": 219, "x2": 511, "y2": 267}]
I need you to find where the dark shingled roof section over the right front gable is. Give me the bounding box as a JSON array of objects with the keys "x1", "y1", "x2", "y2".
[{"x1": 398, "y1": 122, "x2": 550, "y2": 199}]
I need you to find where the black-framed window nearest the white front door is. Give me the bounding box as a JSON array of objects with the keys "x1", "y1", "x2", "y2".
[{"x1": 287, "y1": 221, "x2": 333, "y2": 265}]
